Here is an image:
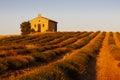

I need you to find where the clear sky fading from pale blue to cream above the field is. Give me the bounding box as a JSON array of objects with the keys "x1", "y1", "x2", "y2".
[{"x1": 0, "y1": 0, "x2": 120, "y2": 35}]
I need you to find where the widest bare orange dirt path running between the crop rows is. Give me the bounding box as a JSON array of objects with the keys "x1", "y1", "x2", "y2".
[{"x1": 96, "y1": 33, "x2": 120, "y2": 80}]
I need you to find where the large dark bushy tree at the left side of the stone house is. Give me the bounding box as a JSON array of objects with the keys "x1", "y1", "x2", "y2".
[{"x1": 20, "y1": 21, "x2": 31, "y2": 35}]
